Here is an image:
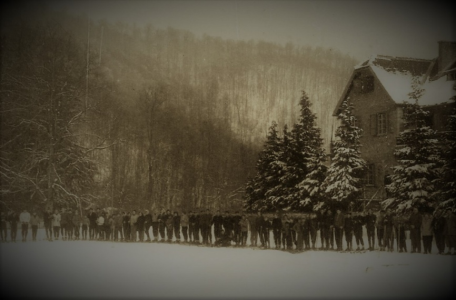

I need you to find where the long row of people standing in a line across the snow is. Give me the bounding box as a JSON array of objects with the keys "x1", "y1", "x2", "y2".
[{"x1": 1, "y1": 208, "x2": 456, "y2": 255}]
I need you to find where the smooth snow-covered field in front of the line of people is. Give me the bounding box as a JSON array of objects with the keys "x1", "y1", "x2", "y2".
[{"x1": 1, "y1": 233, "x2": 456, "y2": 299}]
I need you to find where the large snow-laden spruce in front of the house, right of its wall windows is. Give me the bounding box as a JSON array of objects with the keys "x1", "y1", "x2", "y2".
[{"x1": 382, "y1": 82, "x2": 443, "y2": 211}]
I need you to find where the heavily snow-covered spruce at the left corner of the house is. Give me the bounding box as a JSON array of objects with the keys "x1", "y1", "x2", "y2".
[{"x1": 322, "y1": 100, "x2": 366, "y2": 207}]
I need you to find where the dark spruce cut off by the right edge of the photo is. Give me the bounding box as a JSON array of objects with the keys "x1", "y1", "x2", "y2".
[{"x1": 434, "y1": 105, "x2": 456, "y2": 212}]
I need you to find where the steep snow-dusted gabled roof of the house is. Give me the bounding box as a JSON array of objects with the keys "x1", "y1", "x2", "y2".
[{"x1": 334, "y1": 55, "x2": 456, "y2": 115}]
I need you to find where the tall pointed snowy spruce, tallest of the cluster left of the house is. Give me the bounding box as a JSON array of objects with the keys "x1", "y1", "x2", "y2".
[{"x1": 281, "y1": 91, "x2": 326, "y2": 210}]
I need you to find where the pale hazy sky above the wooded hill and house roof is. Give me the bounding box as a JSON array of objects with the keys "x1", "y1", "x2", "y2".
[{"x1": 8, "y1": 0, "x2": 456, "y2": 60}]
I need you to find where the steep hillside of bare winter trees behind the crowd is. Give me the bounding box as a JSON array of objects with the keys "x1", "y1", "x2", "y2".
[{"x1": 0, "y1": 10, "x2": 356, "y2": 209}]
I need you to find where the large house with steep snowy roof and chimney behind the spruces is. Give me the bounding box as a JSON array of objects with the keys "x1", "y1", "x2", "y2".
[{"x1": 333, "y1": 42, "x2": 456, "y2": 206}]
